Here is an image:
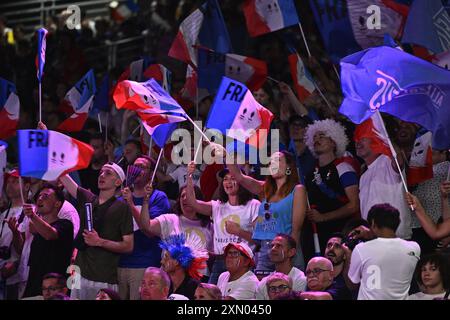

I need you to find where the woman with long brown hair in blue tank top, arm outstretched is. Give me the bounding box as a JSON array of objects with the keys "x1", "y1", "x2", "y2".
[{"x1": 228, "y1": 151, "x2": 306, "y2": 272}]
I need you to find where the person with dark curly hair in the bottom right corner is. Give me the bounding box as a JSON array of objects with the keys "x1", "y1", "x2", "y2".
[{"x1": 408, "y1": 253, "x2": 450, "y2": 300}]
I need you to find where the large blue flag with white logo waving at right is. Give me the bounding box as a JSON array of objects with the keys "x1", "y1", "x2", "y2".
[{"x1": 339, "y1": 46, "x2": 450, "y2": 149}]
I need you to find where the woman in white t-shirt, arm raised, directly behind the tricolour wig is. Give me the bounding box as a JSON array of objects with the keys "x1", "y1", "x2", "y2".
[{"x1": 137, "y1": 184, "x2": 212, "y2": 252}]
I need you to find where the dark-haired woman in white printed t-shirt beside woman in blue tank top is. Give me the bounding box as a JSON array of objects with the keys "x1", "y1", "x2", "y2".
[{"x1": 187, "y1": 162, "x2": 260, "y2": 284}]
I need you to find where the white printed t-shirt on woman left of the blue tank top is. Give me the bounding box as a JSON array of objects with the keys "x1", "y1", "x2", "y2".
[{"x1": 211, "y1": 199, "x2": 261, "y2": 255}]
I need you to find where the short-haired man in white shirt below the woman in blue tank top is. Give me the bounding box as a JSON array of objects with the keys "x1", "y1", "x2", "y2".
[{"x1": 256, "y1": 233, "x2": 306, "y2": 300}]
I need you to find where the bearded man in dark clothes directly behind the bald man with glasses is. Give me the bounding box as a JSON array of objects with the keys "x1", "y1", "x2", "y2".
[{"x1": 325, "y1": 233, "x2": 356, "y2": 300}]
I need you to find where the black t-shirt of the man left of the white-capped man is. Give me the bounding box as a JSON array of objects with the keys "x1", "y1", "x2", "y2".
[{"x1": 25, "y1": 219, "x2": 73, "y2": 297}]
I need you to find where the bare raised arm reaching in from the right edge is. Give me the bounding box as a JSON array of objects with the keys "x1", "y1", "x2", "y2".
[{"x1": 406, "y1": 192, "x2": 450, "y2": 240}]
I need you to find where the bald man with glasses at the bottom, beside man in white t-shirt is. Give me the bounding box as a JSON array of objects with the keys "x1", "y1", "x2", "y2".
[{"x1": 301, "y1": 257, "x2": 349, "y2": 300}]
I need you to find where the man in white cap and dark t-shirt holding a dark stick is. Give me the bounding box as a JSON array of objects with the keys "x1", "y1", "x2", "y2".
[{"x1": 60, "y1": 162, "x2": 133, "y2": 300}]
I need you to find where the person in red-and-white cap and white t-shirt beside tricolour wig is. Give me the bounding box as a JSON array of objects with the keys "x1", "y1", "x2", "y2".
[{"x1": 217, "y1": 242, "x2": 259, "y2": 300}]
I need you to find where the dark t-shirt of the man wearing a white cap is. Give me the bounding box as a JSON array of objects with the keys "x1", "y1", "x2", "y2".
[{"x1": 75, "y1": 188, "x2": 133, "y2": 284}]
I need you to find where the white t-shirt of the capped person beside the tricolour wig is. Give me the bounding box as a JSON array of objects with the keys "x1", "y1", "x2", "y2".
[{"x1": 217, "y1": 271, "x2": 259, "y2": 300}]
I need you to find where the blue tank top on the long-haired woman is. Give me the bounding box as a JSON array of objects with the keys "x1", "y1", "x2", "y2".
[{"x1": 252, "y1": 188, "x2": 295, "y2": 240}]
